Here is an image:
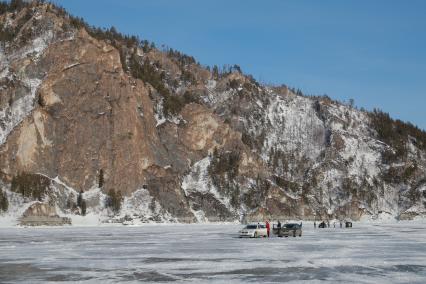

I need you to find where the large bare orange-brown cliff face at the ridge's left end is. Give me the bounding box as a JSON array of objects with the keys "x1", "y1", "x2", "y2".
[{"x1": 0, "y1": 2, "x2": 195, "y2": 221}]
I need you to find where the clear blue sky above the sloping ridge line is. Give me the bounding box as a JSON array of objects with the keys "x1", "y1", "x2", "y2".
[{"x1": 53, "y1": 0, "x2": 426, "y2": 129}]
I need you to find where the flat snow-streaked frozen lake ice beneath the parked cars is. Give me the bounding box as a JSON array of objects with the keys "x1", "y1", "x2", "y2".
[{"x1": 0, "y1": 222, "x2": 426, "y2": 283}]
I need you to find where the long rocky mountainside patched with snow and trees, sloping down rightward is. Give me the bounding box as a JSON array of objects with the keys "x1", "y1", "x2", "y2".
[{"x1": 0, "y1": 3, "x2": 426, "y2": 222}]
